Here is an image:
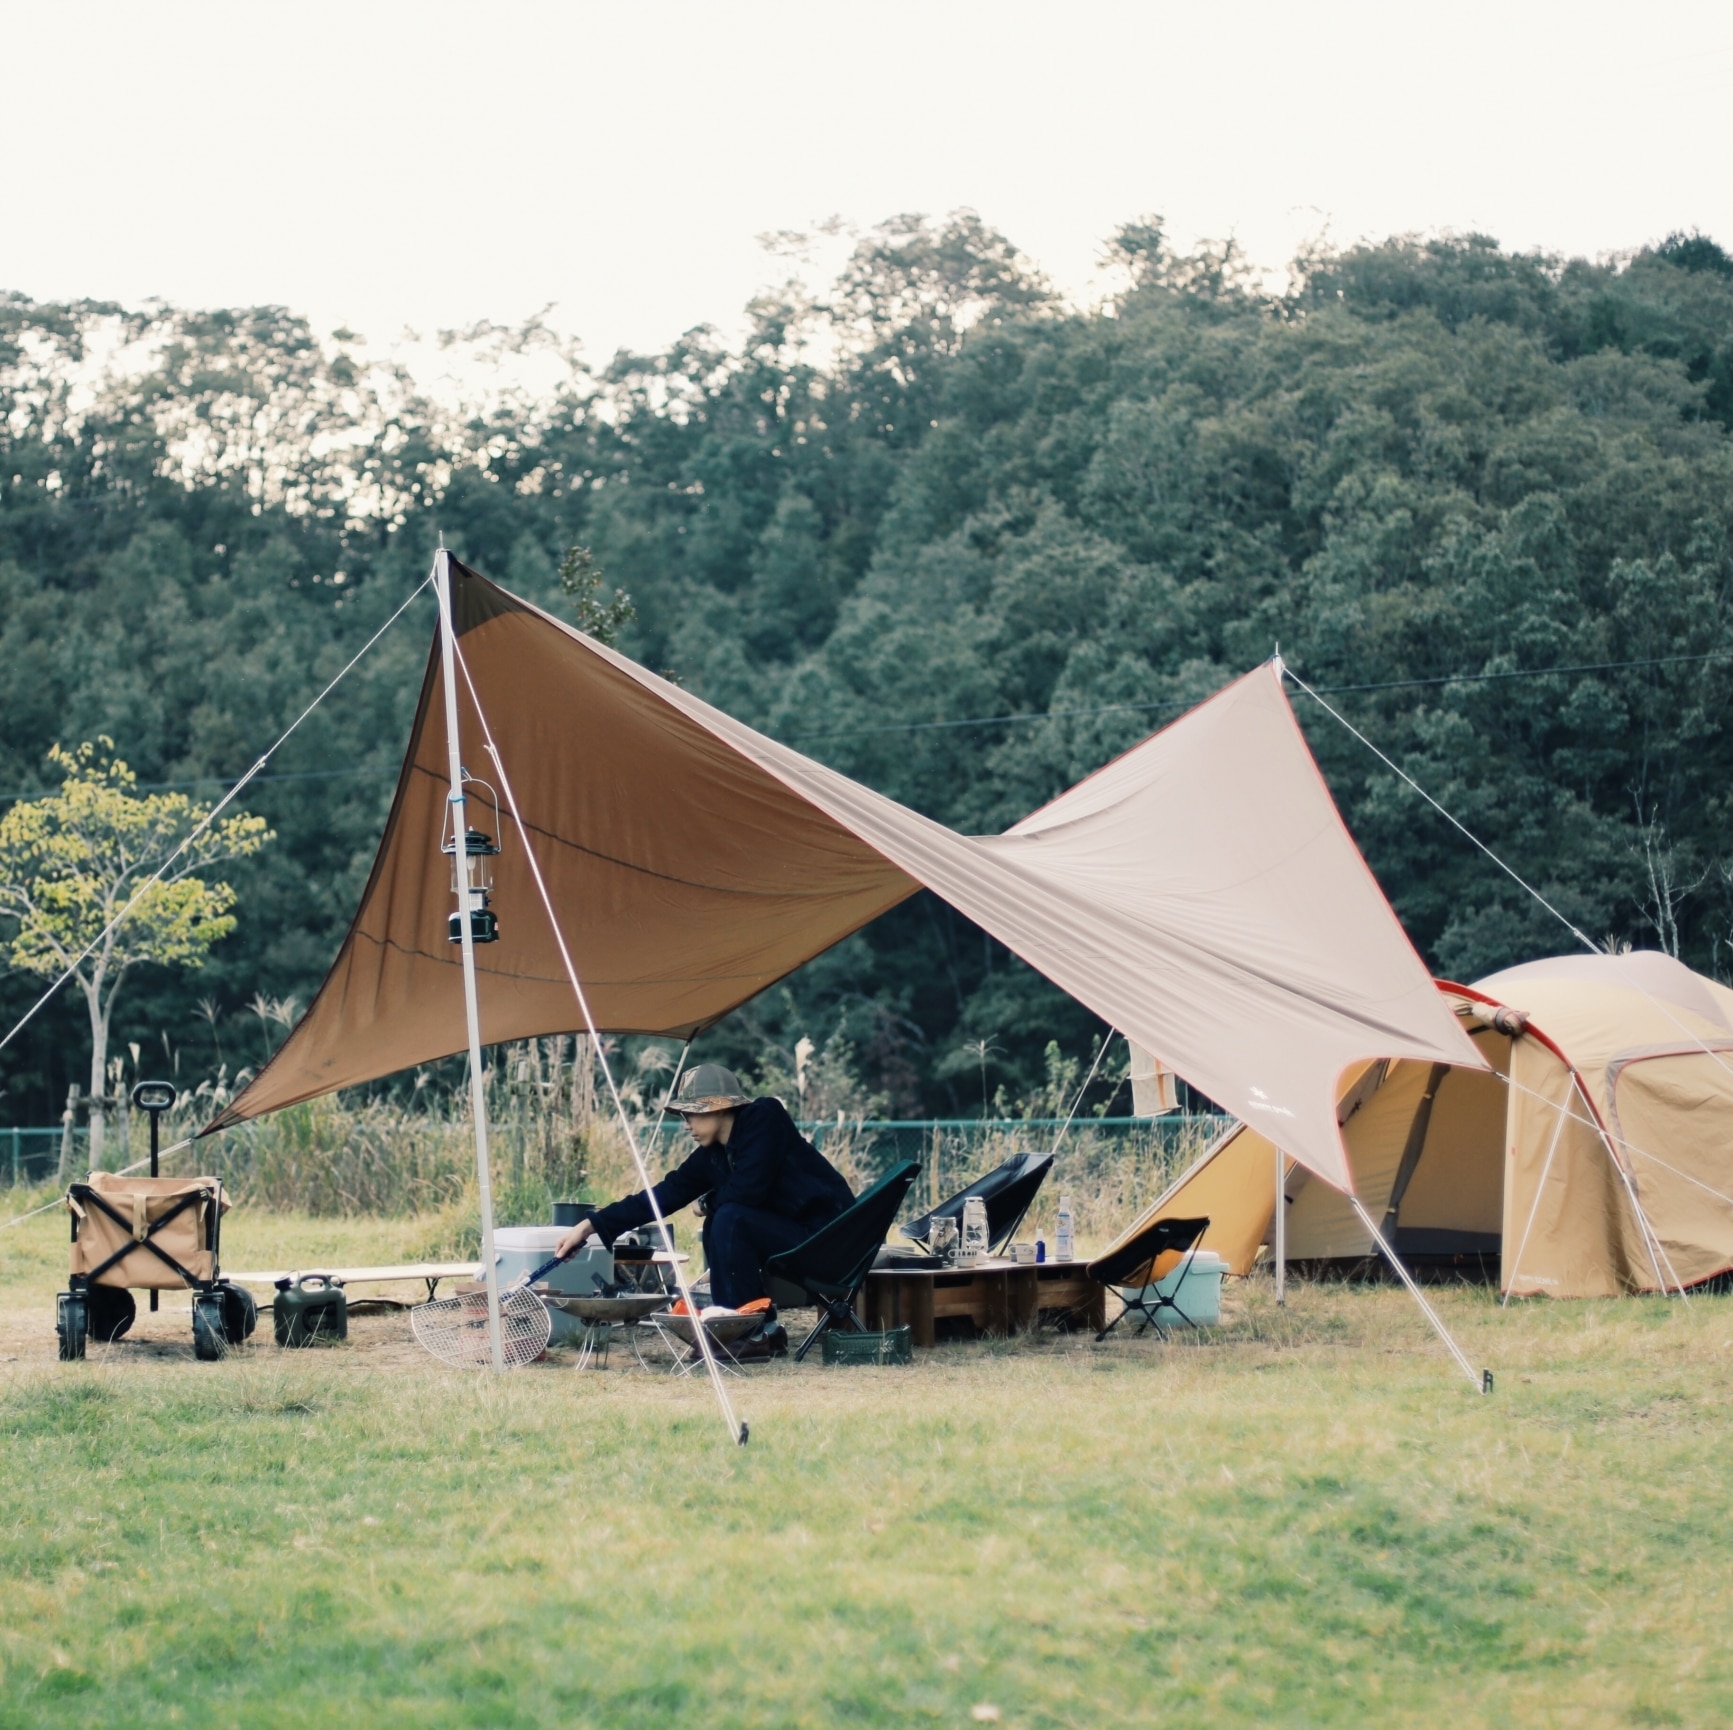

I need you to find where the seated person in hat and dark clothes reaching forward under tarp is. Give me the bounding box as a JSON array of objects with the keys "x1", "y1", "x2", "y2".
[{"x1": 560, "y1": 1063, "x2": 854, "y2": 1357}]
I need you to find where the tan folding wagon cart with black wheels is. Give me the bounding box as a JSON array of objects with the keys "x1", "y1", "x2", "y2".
[{"x1": 55, "y1": 1172, "x2": 258, "y2": 1361}]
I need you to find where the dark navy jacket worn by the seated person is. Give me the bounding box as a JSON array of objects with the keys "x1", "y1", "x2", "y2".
[{"x1": 591, "y1": 1099, "x2": 854, "y2": 1245}]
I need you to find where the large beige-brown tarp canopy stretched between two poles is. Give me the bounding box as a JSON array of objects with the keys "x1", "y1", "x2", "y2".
[{"x1": 211, "y1": 562, "x2": 1478, "y2": 1184}]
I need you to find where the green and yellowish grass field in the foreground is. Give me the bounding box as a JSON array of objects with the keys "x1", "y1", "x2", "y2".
[{"x1": 0, "y1": 1210, "x2": 1733, "y2": 1730}]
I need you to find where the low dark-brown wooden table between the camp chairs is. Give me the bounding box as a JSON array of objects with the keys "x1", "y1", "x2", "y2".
[{"x1": 863, "y1": 1262, "x2": 1107, "y2": 1345}]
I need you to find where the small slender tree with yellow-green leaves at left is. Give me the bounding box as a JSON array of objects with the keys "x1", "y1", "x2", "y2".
[{"x1": 0, "y1": 737, "x2": 272, "y2": 1180}]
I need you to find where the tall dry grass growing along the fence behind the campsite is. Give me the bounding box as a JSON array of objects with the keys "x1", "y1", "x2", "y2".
[{"x1": 14, "y1": 1038, "x2": 1220, "y2": 1257}]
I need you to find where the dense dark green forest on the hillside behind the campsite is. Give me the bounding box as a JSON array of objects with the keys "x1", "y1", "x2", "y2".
[{"x1": 0, "y1": 211, "x2": 1733, "y2": 1123}]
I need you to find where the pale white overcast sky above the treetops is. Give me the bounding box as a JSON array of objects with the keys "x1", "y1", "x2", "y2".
[{"x1": 0, "y1": 0, "x2": 1733, "y2": 361}]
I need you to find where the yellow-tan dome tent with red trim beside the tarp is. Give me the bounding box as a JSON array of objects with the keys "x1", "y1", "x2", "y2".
[{"x1": 1126, "y1": 952, "x2": 1733, "y2": 1297}]
